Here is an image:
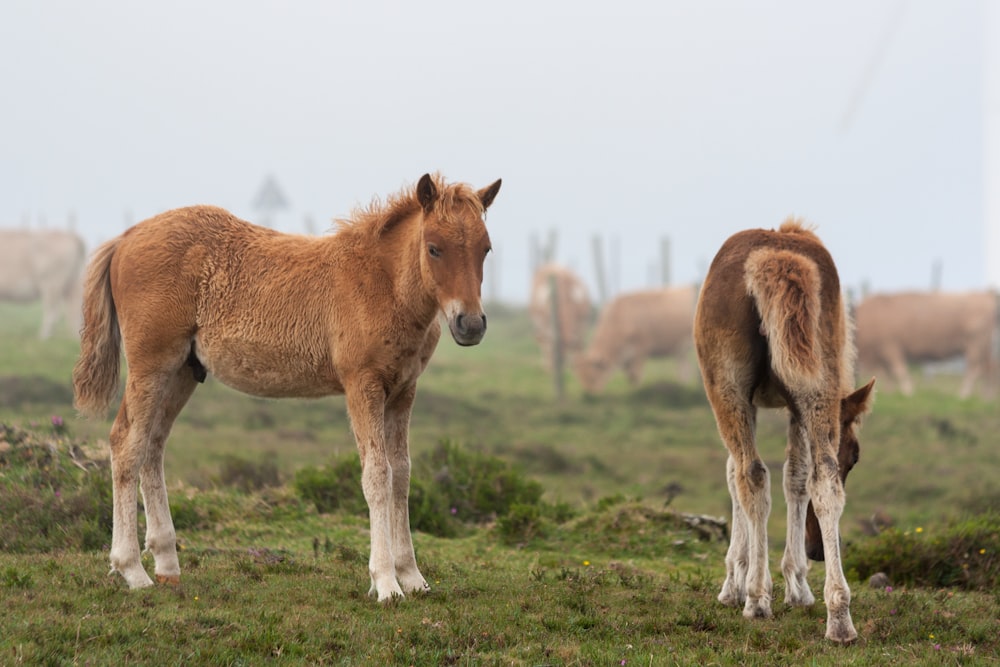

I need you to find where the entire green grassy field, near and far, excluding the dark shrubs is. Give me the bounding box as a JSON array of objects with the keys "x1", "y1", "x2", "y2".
[{"x1": 0, "y1": 306, "x2": 1000, "y2": 665}]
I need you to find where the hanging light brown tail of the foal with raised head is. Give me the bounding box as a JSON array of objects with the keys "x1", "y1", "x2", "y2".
[{"x1": 73, "y1": 238, "x2": 122, "y2": 417}]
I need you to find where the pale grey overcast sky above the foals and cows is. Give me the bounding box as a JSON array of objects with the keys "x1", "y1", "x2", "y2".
[{"x1": 0, "y1": 0, "x2": 986, "y2": 302}]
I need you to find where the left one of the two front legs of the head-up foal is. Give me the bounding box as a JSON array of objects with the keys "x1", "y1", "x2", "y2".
[{"x1": 345, "y1": 377, "x2": 403, "y2": 602}]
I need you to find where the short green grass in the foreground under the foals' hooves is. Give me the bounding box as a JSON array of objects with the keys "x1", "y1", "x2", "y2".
[{"x1": 0, "y1": 505, "x2": 1000, "y2": 665}]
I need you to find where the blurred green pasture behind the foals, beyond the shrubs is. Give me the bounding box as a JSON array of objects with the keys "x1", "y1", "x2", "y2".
[{"x1": 0, "y1": 294, "x2": 1000, "y2": 549}]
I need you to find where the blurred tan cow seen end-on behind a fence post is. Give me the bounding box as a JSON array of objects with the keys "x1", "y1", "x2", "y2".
[{"x1": 528, "y1": 263, "x2": 592, "y2": 370}]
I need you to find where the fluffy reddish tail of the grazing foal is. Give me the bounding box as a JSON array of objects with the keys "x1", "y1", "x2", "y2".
[{"x1": 744, "y1": 248, "x2": 824, "y2": 389}]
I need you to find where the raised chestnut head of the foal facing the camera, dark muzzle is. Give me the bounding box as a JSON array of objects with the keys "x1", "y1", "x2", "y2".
[{"x1": 417, "y1": 174, "x2": 500, "y2": 345}]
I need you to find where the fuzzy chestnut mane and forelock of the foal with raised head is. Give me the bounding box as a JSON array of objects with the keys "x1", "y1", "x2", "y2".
[{"x1": 334, "y1": 173, "x2": 485, "y2": 239}]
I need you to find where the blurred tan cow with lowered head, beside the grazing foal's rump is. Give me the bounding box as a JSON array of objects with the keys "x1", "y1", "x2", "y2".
[{"x1": 576, "y1": 285, "x2": 698, "y2": 393}]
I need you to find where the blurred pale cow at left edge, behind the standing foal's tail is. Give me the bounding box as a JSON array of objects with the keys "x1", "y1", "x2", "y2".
[{"x1": 0, "y1": 229, "x2": 87, "y2": 339}]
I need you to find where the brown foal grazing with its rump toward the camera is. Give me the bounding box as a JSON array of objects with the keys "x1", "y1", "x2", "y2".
[{"x1": 694, "y1": 220, "x2": 874, "y2": 643}]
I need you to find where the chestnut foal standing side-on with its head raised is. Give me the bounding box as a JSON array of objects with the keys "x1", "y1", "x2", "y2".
[{"x1": 73, "y1": 174, "x2": 500, "y2": 600}]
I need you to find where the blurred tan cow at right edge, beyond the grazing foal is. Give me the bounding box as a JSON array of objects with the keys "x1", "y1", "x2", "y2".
[{"x1": 854, "y1": 292, "x2": 998, "y2": 398}]
